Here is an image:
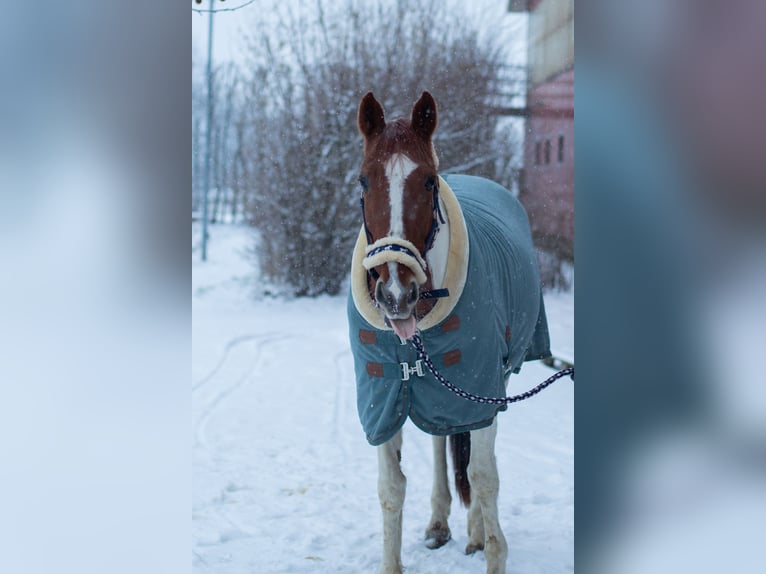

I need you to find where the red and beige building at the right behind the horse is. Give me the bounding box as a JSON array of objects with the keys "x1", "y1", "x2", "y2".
[{"x1": 508, "y1": 0, "x2": 574, "y2": 261}]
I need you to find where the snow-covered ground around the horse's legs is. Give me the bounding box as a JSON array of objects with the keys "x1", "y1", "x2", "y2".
[{"x1": 192, "y1": 226, "x2": 574, "y2": 574}]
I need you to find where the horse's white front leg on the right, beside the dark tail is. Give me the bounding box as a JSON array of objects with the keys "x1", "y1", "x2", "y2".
[{"x1": 468, "y1": 419, "x2": 508, "y2": 574}]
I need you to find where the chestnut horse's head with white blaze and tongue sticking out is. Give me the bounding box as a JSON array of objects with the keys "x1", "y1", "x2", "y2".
[{"x1": 358, "y1": 92, "x2": 441, "y2": 339}]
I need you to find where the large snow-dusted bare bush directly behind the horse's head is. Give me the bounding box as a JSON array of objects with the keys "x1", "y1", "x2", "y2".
[{"x1": 240, "y1": 0, "x2": 512, "y2": 295}]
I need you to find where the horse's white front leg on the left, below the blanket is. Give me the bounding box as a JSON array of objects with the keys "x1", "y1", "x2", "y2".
[{"x1": 378, "y1": 430, "x2": 407, "y2": 574}]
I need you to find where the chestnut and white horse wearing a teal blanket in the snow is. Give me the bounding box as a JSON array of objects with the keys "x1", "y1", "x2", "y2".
[{"x1": 347, "y1": 91, "x2": 550, "y2": 574}]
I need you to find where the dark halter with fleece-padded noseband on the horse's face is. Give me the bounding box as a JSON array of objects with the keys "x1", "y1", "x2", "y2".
[{"x1": 359, "y1": 179, "x2": 449, "y2": 299}]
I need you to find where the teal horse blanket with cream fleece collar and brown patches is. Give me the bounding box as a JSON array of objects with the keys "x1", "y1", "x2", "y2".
[{"x1": 348, "y1": 175, "x2": 550, "y2": 445}]
